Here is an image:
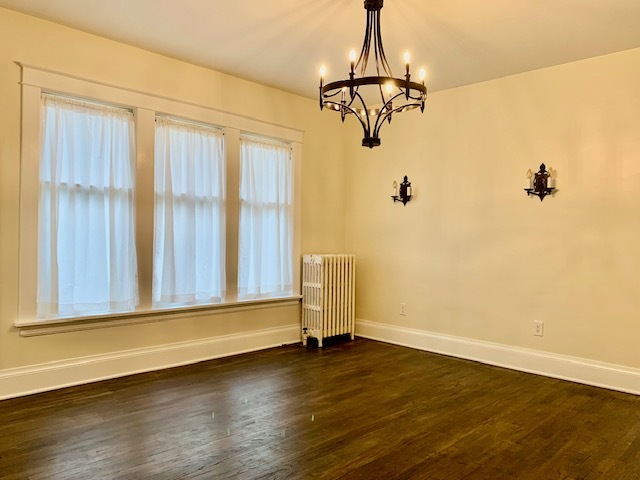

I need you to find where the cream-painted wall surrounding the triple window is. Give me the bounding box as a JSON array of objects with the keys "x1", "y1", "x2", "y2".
[{"x1": 0, "y1": 8, "x2": 344, "y2": 371}]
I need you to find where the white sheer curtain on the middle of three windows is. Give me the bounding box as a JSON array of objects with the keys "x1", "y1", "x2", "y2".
[{"x1": 153, "y1": 117, "x2": 226, "y2": 306}]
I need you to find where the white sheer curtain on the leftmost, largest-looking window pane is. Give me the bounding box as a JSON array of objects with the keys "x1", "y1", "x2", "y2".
[{"x1": 37, "y1": 95, "x2": 138, "y2": 318}]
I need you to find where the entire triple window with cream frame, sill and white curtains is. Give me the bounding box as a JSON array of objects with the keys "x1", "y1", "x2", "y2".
[{"x1": 15, "y1": 65, "x2": 303, "y2": 336}]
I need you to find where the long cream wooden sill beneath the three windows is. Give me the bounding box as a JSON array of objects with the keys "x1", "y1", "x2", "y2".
[{"x1": 13, "y1": 295, "x2": 302, "y2": 337}]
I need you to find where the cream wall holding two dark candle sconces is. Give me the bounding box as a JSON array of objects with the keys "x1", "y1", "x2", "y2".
[{"x1": 346, "y1": 49, "x2": 640, "y2": 368}]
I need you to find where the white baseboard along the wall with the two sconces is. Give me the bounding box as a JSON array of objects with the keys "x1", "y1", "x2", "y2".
[{"x1": 356, "y1": 319, "x2": 640, "y2": 395}]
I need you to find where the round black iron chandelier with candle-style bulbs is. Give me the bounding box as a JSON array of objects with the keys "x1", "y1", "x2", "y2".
[{"x1": 320, "y1": 0, "x2": 427, "y2": 148}]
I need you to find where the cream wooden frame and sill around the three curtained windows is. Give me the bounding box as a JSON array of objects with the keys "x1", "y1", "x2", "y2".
[{"x1": 14, "y1": 62, "x2": 303, "y2": 336}]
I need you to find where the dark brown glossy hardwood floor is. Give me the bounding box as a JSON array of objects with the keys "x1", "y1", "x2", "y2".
[{"x1": 0, "y1": 339, "x2": 640, "y2": 480}]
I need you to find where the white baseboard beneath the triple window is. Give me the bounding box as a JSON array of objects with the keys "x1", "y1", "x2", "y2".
[{"x1": 0, "y1": 324, "x2": 300, "y2": 400}]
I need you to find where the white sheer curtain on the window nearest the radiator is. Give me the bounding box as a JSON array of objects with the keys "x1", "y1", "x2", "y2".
[{"x1": 238, "y1": 136, "x2": 293, "y2": 299}]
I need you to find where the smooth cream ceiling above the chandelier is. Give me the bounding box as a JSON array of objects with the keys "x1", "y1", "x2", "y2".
[{"x1": 0, "y1": 0, "x2": 640, "y2": 98}]
